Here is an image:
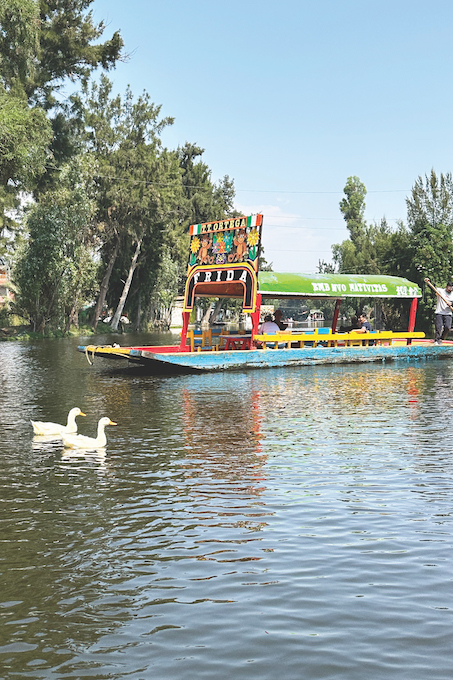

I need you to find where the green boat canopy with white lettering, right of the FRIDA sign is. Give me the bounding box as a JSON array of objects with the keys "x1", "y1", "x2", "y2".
[{"x1": 259, "y1": 272, "x2": 422, "y2": 298}]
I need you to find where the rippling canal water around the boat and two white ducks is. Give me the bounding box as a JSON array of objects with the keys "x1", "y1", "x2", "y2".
[{"x1": 0, "y1": 336, "x2": 453, "y2": 680}]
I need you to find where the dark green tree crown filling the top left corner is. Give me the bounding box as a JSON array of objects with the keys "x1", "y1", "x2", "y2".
[{"x1": 0, "y1": 0, "x2": 123, "y2": 103}]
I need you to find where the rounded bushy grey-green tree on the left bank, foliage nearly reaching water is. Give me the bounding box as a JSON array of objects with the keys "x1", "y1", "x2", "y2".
[{"x1": 13, "y1": 158, "x2": 97, "y2": 332}]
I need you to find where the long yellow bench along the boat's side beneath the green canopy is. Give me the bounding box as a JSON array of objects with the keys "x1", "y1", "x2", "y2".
[{"x1": 253, "y1": 328, "x2": 425, "y2": 349}]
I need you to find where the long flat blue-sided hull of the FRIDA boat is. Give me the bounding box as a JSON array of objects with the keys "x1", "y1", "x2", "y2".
[{"x1": 78, "y1": 343, "x2": 453, "y2": 373}]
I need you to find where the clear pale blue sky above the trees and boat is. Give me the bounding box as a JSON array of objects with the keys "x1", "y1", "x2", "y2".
[{"x1": 91, "y1": 0, "x2": 453, "y2": 272}]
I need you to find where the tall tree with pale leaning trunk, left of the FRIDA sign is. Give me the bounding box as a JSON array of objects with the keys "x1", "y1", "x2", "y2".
[{"x1": 73, "y1": 76, "x2": 177, "y2": 328}]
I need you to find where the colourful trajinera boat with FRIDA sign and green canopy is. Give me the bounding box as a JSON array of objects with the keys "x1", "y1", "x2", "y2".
[{"x1": 78, "y1": 214, "x2": 453, "y2": 373}]
